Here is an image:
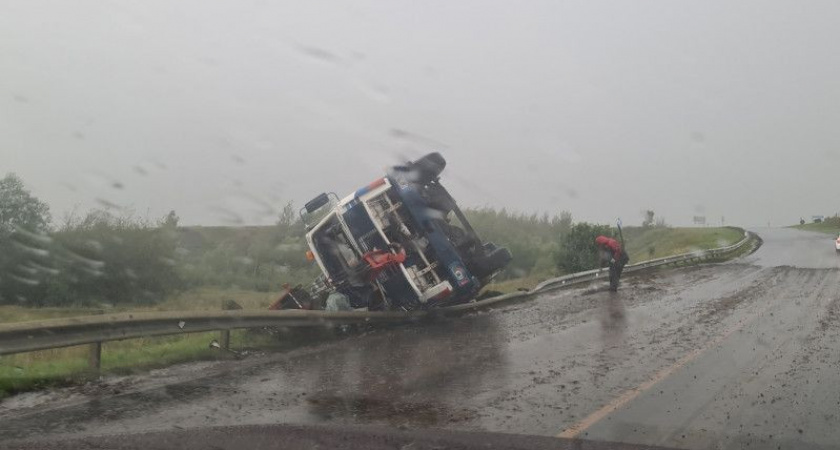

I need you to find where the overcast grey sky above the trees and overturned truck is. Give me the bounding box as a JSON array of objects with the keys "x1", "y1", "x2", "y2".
[{"x1": 0, "y1": 0, "x2": 840, "y2": 229}]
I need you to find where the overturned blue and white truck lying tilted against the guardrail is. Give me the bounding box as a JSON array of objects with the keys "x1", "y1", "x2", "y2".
[{"x1": 272, "y1": 153, "x2": 511, "y2": 310}]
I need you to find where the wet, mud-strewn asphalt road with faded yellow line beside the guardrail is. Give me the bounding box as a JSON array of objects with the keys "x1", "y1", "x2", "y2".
[{"x1": 0, "y1": 229, "x2": 840, "y2": 448}]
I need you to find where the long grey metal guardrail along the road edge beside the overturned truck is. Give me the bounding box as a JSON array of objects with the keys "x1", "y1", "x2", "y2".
[{"x1": 0, "y1": 232, "x2": 761, "y2": 369}]
